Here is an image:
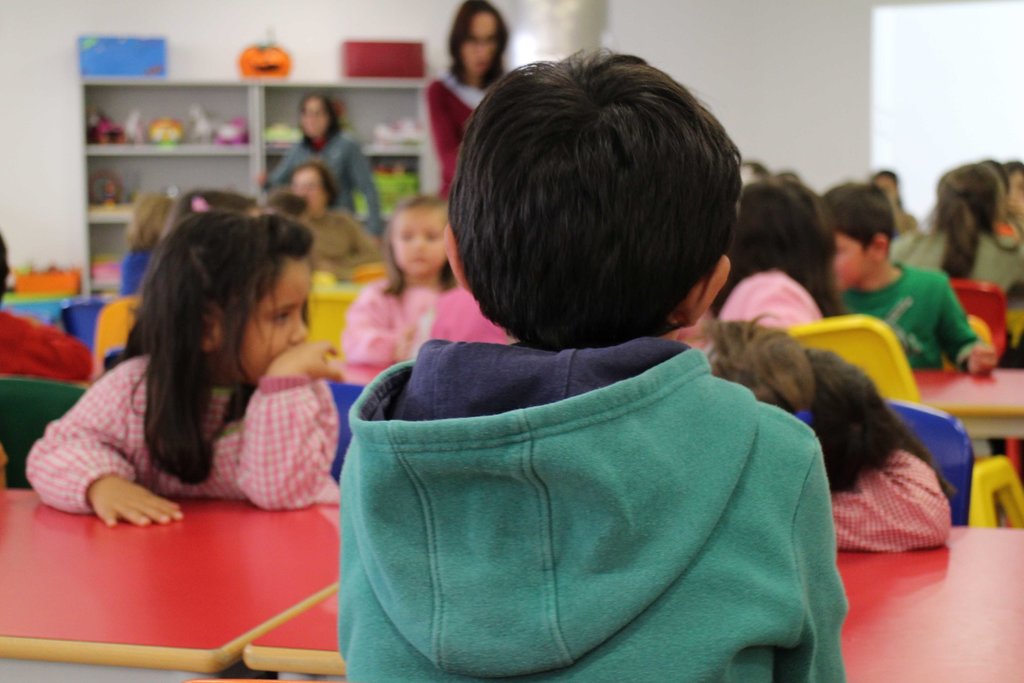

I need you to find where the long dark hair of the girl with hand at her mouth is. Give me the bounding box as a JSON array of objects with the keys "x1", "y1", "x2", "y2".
[{"x1": 125, "y1": 211, "x2": 312, "y2": 483}]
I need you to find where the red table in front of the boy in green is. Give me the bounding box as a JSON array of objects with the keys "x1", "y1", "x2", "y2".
[{"x1": 913, "y1": 370, "x2": 1024, "y2": 438}]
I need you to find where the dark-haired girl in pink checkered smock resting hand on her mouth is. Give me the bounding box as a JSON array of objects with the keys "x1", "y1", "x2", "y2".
[{"x1": 28, "y1": 212, "x2": 338, "y2": 525}]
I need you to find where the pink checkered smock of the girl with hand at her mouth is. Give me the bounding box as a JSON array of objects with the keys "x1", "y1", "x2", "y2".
[{"x1": 28, "y1": 357, "x2": 339, "y2": 513}]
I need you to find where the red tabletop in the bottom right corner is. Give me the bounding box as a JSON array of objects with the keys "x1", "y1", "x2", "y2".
[{"x1": 839, "y1": 526, "x2": 1024, "y2": 683}]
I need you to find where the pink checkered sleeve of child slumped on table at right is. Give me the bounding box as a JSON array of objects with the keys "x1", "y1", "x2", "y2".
[{"x1": 831, "y1": 451, "x2": 951, "y2": 552}]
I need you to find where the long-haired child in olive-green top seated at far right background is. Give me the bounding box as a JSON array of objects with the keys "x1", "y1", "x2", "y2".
[{"x1": 892, "y1": 164, "x2": 1024, "y2": 292}]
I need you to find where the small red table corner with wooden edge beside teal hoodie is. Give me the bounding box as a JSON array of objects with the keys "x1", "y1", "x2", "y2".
[{"x1": 245, "y1": 593, "x2": 345, "y2": 677}]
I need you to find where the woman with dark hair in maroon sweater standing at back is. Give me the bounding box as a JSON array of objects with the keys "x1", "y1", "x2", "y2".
[{"x1": 427, "y1": 0, "x2": 509, "y2": 198}]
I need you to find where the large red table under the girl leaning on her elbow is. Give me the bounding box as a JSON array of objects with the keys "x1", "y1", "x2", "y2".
[{"x1": 0, "y1": 490, "x2": 338, "y2": 680}]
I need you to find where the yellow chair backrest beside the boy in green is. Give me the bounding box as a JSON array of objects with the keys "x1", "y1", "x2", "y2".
[{"x1": 788, "y1": 315, "x2": 921, "y2": 402}]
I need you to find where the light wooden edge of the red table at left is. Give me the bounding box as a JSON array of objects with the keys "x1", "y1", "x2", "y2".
[{"x1": 0, "y1": 582, "x2": 338, "y2": 674}]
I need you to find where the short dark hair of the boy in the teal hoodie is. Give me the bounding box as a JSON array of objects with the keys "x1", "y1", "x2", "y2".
[{"x1": 450, "y1": 52, "x2": 740, "y2": 350}]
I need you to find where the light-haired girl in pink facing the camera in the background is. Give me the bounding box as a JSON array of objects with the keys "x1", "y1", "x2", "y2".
[{"x1": 341, "y1": 197, "x2": 455, "y2": 366}]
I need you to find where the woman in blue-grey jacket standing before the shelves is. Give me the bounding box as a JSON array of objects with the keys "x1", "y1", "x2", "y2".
[{"x1": 266, "y1": 93, "x2": 384, "y2": 236}]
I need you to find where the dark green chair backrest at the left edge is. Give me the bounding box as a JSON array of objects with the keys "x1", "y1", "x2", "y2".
[{"x1": 0, "y1": 377, "x2": 85, "y2": 488}]
